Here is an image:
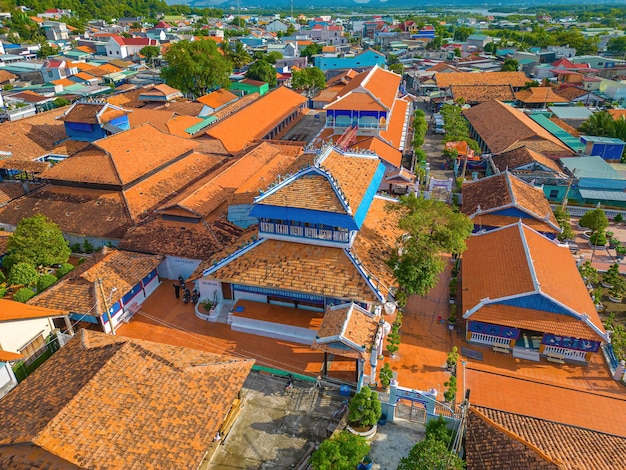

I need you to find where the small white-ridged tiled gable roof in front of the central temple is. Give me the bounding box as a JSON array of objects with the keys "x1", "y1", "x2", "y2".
[{"x1": 311, "y1": 303, "x2": 378, "y2": 360}]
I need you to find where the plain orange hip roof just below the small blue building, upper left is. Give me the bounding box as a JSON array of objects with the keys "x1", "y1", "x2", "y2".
[{"x1": 43, "y1": 124, "x2": 198, "y2": 185}]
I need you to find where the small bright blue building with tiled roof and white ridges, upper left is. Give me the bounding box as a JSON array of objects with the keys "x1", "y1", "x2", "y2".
[{"x1": 60, "y1": 102, "x2": 130, "y2": 142}]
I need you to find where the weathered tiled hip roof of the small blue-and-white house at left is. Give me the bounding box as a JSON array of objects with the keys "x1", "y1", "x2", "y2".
[{"x1": 28, "y1": 247, "x2": 164, "y2": 316}]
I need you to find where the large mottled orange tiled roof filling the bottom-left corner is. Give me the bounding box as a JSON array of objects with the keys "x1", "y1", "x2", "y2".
[{"x1": 0, "y1": 330, "x2": 254, "y2": 470}]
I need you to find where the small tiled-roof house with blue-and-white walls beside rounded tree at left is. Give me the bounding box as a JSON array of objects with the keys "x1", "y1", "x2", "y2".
[{"x1": 28, "y1": 247, "x2": 164, "y2": 334}]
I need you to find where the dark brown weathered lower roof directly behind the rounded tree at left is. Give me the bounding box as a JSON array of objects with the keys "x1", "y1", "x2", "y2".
[{"x1": 0, "y1": 184, "x2": 131, "y2": 239}]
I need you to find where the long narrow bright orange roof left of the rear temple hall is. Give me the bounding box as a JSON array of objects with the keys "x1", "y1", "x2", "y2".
[{"x1": 206, "y1": 87, "x2": 307, "y2": 154}]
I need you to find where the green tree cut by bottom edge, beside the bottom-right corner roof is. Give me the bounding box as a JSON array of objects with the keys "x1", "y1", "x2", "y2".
[{"x1": 397, "y1": 436, "x2": 465, "y2": 470}]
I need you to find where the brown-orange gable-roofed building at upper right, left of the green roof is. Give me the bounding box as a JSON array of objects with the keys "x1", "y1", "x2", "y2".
[{"x1": 460, "y1": 99, "x2": 574, "y2": 159}]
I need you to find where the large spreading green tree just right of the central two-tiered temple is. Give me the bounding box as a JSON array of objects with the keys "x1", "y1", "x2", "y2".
[{"x1": 387, "y1": 194, "x2": 473, "y2": 295}]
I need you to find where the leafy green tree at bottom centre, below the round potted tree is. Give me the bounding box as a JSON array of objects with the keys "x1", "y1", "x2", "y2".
[{"x1": 309, "y1": 431, "x2": 370, "y2": 470}]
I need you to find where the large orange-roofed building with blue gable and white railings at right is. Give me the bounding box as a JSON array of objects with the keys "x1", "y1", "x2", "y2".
[{"x1": 461, "y1": 221, "x2": 609, "y2": 364}]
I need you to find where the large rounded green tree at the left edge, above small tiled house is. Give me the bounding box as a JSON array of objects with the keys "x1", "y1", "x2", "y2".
[{"x1": 7, "y1": 214, "x2": 70, "y2": 266}]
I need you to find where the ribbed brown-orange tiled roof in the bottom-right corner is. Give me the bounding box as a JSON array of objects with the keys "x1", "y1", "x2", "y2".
[{"x1": 466, "y1": 406, "x2": 626, "y2": 470}]
